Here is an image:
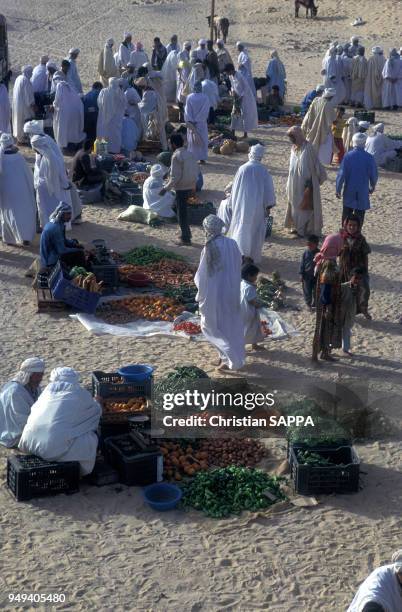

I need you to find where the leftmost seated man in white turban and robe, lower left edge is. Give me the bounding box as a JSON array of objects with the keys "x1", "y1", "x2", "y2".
[{"x1": 0, "y1": 357, "x2": 45, "y2": 448}]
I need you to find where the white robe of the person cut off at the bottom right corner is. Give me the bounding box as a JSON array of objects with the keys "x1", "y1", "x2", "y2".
[{"x1": 347, "y1": 565, "x2": 402, "y2": 612}]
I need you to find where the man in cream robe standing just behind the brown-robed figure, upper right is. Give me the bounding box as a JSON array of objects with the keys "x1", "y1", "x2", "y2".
[{"x1": 302, "y1": 89, "x2": 335, "y2": 165}]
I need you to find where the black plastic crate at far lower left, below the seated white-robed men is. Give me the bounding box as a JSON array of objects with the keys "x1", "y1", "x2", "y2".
[{"x1": 7, "y1": 455, "x2": 80, "y2": 501}]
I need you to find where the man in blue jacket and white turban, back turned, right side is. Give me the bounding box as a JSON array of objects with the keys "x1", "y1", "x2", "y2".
[{"x1": 336, "y1": 133, "x2": 378, "y2": 227}]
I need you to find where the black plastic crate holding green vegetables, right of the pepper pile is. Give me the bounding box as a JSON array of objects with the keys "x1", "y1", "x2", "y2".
[{"x1": 290, "y1": 446, "x2": 360, "y2": 495}]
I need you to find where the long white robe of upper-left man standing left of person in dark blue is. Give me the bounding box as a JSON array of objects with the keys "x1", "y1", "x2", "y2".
[{"x1": 53, "y1": 81, "x2": 85, "y2": 149}]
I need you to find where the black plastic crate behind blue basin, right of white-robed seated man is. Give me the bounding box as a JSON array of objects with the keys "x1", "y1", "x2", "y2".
[{"x1": 105, "y1": 433, "x2": 163, "y2": 487}]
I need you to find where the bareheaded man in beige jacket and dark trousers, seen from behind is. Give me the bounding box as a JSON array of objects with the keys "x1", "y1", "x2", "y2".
[{"x1": 159, "y1": 134, "x2": 199, "y2": 246}]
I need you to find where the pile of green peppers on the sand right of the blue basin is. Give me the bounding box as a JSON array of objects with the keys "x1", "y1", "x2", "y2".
[{"x1": 182, "y1": 466, "x2": 286, "y2": 518}]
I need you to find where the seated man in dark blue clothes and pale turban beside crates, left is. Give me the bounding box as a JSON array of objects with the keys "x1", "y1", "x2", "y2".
[{"x1": 40, "y1": 202, "x2": 86, "y2": 268}]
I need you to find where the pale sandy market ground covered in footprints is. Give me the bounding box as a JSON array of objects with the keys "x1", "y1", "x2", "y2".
[{"x1": 0, "y1": 0, "x2": 402, "y2": 612}]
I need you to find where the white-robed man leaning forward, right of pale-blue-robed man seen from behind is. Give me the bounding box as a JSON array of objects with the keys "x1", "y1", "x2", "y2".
[{"x1": 225, "y1": 64, "x2": 258, "y2": 138}]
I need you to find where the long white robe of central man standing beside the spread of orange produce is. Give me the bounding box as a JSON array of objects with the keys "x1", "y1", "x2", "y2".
[{"x1": 194, "y1": 236, "x2": 245, "y2": 370}]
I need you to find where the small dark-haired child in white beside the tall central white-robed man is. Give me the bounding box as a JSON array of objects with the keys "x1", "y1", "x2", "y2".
[{"x1": 240, "y1": 263, "x2": 264, "y2": 350}]
